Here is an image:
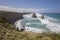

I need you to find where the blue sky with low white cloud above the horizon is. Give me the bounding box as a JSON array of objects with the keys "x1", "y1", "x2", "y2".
[{"x1": 0, "y1": 0, "x2": 60, "y2": 13}]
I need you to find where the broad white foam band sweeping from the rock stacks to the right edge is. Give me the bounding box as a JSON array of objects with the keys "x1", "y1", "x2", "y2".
[{"x1": 38, "y1": 15, "x2": 60, "y2": 33}]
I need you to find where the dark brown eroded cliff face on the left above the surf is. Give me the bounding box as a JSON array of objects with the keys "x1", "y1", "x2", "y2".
[{"x1": 0, "y1": 12, "x2": 30, "y2": 24}]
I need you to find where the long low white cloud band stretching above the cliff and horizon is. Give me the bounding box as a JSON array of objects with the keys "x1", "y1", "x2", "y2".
[{"x1": 0, "y1": 5, "x2": 48, "y2": 12}]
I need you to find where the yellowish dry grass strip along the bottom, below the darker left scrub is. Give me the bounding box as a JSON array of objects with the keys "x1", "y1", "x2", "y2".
[{"x1": 0, "y1": 28, "x2": 60, "y2": 40}]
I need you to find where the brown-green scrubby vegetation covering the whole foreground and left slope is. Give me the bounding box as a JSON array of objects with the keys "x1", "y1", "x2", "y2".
[{"x1": 0, "y1": 18, "x2": 60, "y2": 40}]
